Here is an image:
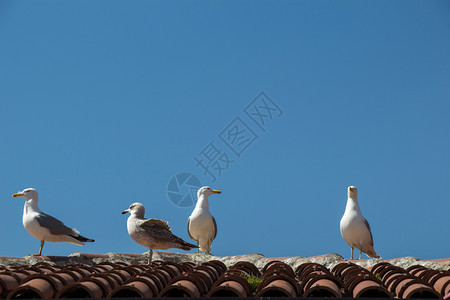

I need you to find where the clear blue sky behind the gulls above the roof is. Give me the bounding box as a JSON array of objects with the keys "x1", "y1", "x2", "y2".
[{"x1": 0, "y1": 0, "x2": 450, "y2": 259}]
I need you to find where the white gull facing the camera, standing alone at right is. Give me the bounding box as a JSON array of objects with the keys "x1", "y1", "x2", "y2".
[{"x1": 341, "y1": 186, "x2": 381, "y2": 259}]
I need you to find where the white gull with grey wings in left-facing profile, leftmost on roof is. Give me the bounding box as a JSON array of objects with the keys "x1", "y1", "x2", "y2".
[{"x1": 13, "y1": 188, "x2": 95, "y2": 256}]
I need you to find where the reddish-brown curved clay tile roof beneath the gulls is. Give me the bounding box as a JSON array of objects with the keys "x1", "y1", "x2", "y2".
[{"x1": 0, "y1": 252, "x2": 450, "y2": 299}]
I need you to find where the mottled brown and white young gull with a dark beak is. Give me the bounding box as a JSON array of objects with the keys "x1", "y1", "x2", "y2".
[{"x1": 122, "y1": 202, "x2": 197, "y2": 264}]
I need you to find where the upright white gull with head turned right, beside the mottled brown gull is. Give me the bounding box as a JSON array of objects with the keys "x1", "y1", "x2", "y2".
[{"x1": 187, "y1": 186, "x2": 222, "y2": 254}]
